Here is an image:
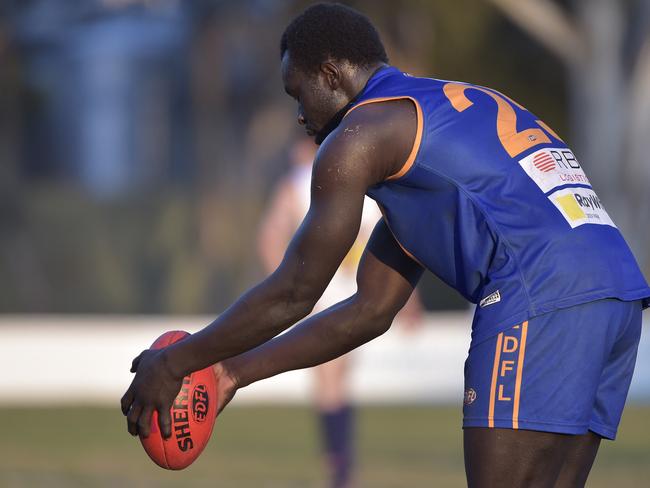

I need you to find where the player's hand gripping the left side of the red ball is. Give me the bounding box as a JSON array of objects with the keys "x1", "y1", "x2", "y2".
[{"x1": 121, "y1": 349, "x2": 183, "y2": 439}]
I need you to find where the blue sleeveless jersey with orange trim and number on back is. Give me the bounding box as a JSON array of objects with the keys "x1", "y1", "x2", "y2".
[{"x1": 344, "y1": 67, "x2": 650, "y2": 341}]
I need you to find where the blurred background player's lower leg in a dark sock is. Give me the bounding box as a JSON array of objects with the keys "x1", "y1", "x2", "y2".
[{"x1": 314, "y1": 356, "x2": 354, "y2": 488}]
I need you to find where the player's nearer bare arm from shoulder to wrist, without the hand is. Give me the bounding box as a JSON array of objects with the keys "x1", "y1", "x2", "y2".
[{"x1": 167, "y1": 127, "x2": 379, "y2": 375}]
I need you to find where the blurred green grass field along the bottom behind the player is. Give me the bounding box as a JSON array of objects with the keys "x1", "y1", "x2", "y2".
[{"x1": 0, "y1": 406, "x2": 650, "y2": 488}]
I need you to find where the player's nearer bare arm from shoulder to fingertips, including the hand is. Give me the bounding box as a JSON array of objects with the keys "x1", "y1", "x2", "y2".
[{"x1": 121, "y1": 101, "x2": 416, "y2": 436}]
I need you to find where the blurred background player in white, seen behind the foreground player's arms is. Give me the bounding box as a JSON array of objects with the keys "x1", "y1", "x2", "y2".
[{"x1": 258, "y1": 138, "x2": 422, "y2": 488}]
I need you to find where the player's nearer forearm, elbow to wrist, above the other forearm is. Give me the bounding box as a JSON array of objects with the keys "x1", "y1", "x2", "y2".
[{"x1": 165, "y1": 276, "x2": 315, "y2": 376}]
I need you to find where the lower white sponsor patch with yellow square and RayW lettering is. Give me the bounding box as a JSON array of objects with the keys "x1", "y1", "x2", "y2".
[{"x1": 548, "y1": 188, "x2": 616, "y2": 228}]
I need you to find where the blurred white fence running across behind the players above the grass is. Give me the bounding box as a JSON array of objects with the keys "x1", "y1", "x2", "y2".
[{"x1": 0, "y1": 313, "x2": 650, "y2": 408}]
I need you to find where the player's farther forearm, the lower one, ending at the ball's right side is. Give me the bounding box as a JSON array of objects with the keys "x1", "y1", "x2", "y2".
[{"x1": 224, "y1": 297, "x2": 395, "y2": 387}]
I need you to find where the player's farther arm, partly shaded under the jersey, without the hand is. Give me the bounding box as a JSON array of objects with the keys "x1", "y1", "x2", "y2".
[{"x1": 224, "y1": 220, "x2": 423, "y2": 387}]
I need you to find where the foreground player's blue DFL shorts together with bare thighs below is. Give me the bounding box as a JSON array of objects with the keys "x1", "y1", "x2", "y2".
[{"x1": 464, "y1": 300, "x2": 640, "y2": 486}]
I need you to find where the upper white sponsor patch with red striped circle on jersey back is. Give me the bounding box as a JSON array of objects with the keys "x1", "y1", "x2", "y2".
[{"x1": 519, "y1": 148, "x2": 591, "y2": 193}]
